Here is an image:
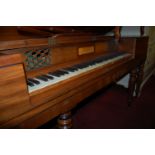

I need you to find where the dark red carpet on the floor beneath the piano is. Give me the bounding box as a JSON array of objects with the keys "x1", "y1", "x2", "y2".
[{"x1": 41, "y1": 76, "x2": 155, "y2": 129}]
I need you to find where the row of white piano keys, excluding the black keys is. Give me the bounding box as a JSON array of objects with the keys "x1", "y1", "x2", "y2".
[{"x1": 28, "y1": 54, "x2": 130, "y2": 93}]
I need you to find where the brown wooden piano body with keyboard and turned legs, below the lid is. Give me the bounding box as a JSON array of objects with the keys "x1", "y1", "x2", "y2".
[{"x1": 0, "y1": 35, "x2": 148, "y2": 128}]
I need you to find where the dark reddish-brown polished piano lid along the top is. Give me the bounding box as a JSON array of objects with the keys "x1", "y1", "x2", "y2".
[{"x1": 0, "y1": 26, "x2": 115, "y2": 41}]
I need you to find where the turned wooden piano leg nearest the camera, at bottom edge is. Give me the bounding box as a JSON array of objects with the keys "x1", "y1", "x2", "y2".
[{"x1": 57, "y1": 112, "x2": 72, "y2": 129}]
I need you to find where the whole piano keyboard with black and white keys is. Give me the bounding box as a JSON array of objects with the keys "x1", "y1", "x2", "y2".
[{"x1": 27, "y1": 52, "x2": 130, "y2": 93}]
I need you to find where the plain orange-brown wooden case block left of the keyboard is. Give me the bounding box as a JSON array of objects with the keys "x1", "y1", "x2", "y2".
[{"x1": 0, "y1": 64, "x2": 32, "y2": 125}]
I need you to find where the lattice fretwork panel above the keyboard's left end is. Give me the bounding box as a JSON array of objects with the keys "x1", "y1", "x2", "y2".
[{"x1": 24, "y1": 48, "x2": 51, "y2": 70}]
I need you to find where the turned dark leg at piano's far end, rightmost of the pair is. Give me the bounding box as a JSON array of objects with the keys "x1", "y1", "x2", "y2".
[{"x1": 135, "y1": 64, "x2": 144, "y2": 97}]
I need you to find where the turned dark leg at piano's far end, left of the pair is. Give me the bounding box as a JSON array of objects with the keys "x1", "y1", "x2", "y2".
[{"x1": 128, "y1": 69, "x2": 137, "y2": 106}]
